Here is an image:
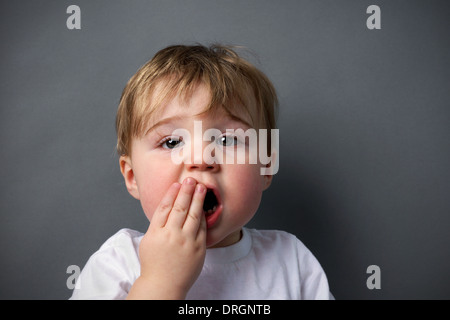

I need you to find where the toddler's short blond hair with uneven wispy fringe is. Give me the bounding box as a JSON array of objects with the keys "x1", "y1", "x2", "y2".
[{"x1": 116, "y1": 45, "x2": 278, "y2": 155}]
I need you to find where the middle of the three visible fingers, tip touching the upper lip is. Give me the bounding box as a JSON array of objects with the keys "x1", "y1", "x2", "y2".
[{"x1": 166, "y1": 178, "x2": 196, "y2": 228}]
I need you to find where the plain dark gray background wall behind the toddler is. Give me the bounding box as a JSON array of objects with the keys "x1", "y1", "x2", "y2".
[{"x1": 0, "y1": 0, "x2": 450, "y2": 299}]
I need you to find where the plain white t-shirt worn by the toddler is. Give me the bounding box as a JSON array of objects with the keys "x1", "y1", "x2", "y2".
[{"x1": 70, "y1": 228, "x2": 333, "y2": 300}]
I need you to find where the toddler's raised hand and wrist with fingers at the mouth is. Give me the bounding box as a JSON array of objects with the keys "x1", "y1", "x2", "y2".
[{"x1": 127, "y1": 178, "x2": 206, "y2": 299}]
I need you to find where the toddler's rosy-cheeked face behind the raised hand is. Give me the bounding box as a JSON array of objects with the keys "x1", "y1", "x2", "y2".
[{"x1": 120, "y1": 85, "x2": 272, "y2": 247}]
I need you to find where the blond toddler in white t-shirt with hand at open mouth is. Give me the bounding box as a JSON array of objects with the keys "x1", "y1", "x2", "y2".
[{"x1": 71, "y1": 46, "x2": 332, "y2": 299}]
